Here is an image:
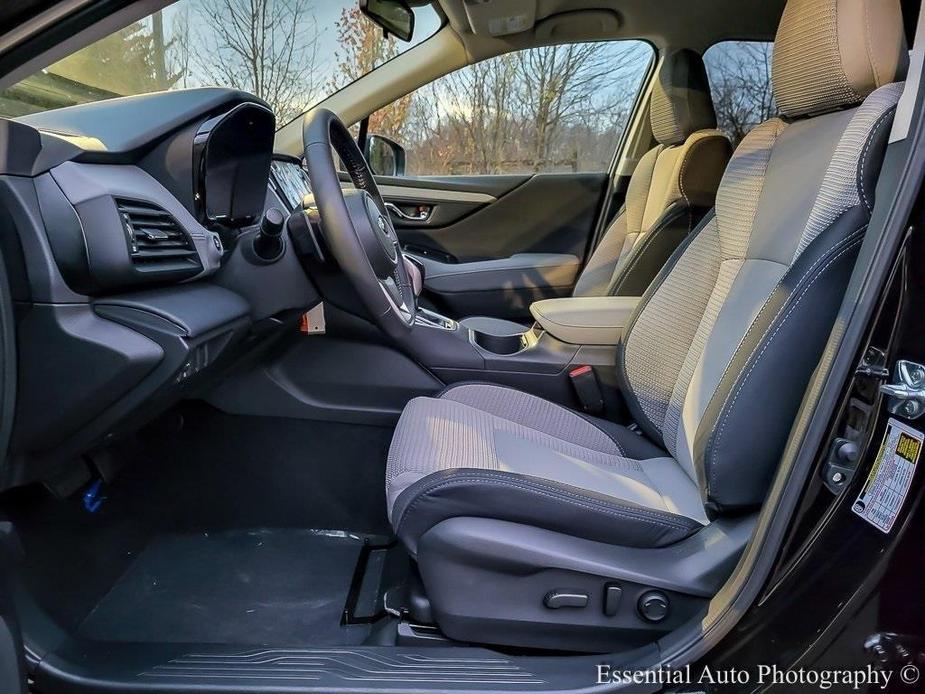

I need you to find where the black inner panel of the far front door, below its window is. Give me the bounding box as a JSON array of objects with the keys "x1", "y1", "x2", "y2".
[{"x1": 377, "y1": 173, "x2": 608, "y2": 319}]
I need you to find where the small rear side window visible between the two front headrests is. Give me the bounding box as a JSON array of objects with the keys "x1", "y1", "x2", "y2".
[{"x1": 703, "y1": 41, "x2": 777, "y2": 146}]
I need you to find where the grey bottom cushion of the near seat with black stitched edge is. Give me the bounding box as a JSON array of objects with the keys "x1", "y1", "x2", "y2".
[{"x1": 386, "y1": 383, "x2": 707, "y2": 551}]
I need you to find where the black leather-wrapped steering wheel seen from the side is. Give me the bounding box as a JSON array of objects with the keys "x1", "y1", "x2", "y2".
[{"x1": 302, "y1": 108, "x2": 417, "y2": 337}]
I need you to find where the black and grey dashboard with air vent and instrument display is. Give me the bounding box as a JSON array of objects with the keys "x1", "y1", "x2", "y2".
[{"x1": 0, "y1": 88, "x2": 319, "y2": 489}]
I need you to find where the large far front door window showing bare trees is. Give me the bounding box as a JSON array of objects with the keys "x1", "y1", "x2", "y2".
[{"x1": 369, "y1": 41, "x2": 652, "y2": 176}]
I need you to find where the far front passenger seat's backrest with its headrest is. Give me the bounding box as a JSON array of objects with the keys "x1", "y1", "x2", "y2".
[{"x1": 573, "y1": 49, "x2": 732, "y2": 296}]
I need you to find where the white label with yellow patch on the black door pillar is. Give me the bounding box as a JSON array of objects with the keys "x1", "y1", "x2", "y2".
[{"x1": 851, "y1": 418, "x2": 925, "y2": 533}]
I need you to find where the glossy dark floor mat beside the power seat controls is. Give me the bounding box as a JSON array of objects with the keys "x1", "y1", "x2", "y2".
[{"x1": 79, "y1": 529, "x2": 378, "y2": 646}]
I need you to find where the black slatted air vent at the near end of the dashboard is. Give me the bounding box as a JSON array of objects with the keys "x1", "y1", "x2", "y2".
[{"x1": 116, "y1": 199, "x2": 202, "y2": 271}]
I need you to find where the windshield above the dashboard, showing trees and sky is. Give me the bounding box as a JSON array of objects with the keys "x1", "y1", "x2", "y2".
[{"x1": 0, "y1": 0, "x2": 440, "y2": 124}]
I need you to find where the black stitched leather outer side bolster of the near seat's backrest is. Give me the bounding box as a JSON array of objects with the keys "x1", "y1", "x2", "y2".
[{"x1": 694, "y1": 206, "x2": 868, "y2": 511}]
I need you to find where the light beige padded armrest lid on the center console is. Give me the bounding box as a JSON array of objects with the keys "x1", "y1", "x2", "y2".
[{"x1": 530, "y1": 296, "x2": 639, "y2": 345}]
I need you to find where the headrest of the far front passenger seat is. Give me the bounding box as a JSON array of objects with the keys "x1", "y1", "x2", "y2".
[{"x1": 649, "y1": 48, "x2": 716, "y2": 145}]
